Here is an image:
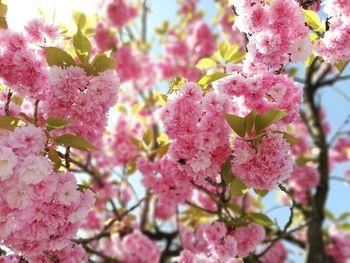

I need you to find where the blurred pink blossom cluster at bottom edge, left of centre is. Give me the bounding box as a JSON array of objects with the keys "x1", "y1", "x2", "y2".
[{"x1": 112, "y1": 230, "x2": 160, "y2": 263}]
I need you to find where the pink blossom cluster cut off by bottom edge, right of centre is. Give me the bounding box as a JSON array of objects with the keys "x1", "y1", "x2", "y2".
[{"x1": 179, "y1": 222, "x2": 265, "y2": 263}]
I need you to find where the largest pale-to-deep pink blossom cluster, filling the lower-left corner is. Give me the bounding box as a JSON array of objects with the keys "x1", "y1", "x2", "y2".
[{"x1": 0, "y1": 125, "x2": 94, "y2": 262}]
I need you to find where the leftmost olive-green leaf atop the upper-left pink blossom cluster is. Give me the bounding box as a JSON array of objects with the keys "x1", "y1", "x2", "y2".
[{"x1": 43, "y1": 47, "x2": 75, "y2": 68}]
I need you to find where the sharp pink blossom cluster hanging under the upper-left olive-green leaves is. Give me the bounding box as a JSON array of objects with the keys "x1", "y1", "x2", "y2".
[{"x1": 44, "y1": 66, "x2": 119, "y2": 142}]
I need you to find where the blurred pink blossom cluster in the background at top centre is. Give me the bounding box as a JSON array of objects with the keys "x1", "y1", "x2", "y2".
[{"x1": 158, "y1": 19, "x2": 216, "y2": 81}]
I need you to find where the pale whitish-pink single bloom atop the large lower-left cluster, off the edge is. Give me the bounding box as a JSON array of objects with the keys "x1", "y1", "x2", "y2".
[{"x1": 19, "y1": 155, "x2": 52, "y2": 184}]
